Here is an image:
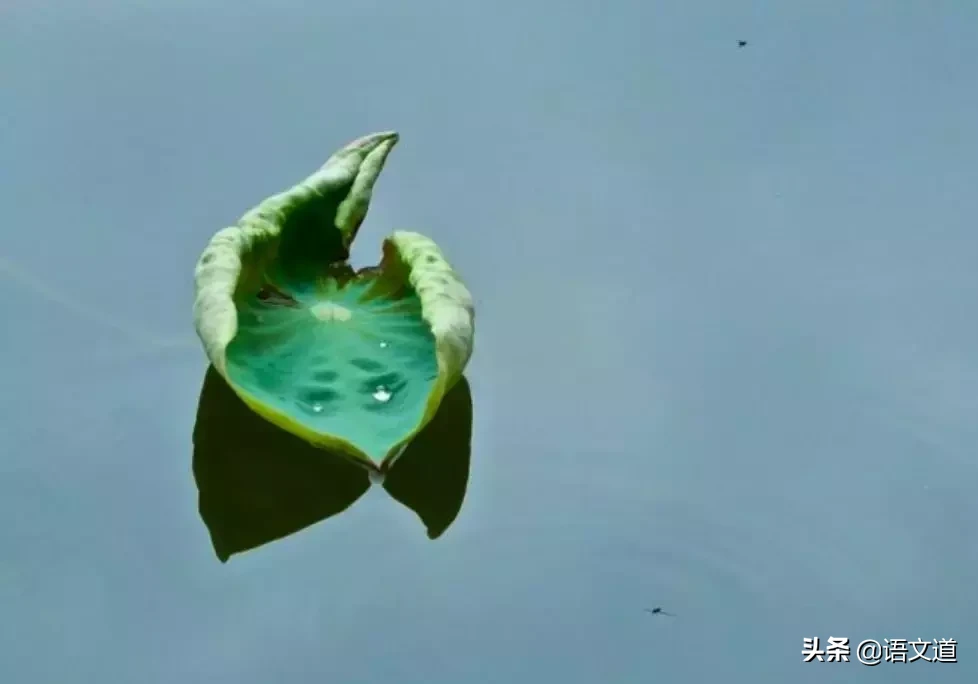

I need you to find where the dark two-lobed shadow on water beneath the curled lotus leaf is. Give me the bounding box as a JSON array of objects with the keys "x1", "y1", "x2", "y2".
[{"x1": 193, "y1": 367, "x2": 472, "y2": 562}]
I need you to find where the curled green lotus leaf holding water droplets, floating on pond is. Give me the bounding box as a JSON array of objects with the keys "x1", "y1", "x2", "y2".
[{"x1": 194, "y1": 132, "x2": 475, "y2": 473}]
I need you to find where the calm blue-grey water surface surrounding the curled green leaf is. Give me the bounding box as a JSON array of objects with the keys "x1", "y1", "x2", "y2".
[{"x1": 0, "y1": 0, "x2": 978, "y2": 684}]
